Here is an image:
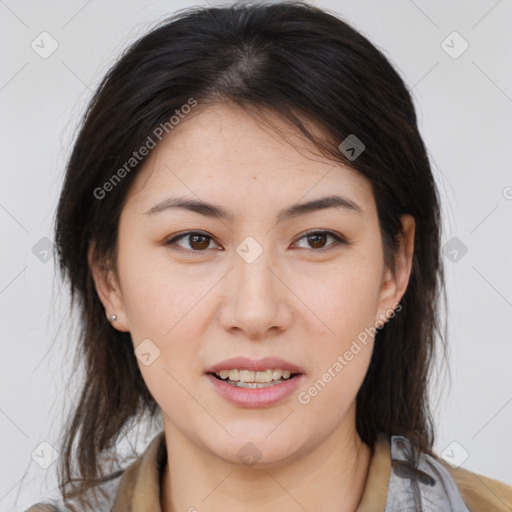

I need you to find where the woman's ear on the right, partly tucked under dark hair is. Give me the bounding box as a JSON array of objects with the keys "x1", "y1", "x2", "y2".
[{"x1": 375, "y1": 215, "x2": 416, "y2": 327}]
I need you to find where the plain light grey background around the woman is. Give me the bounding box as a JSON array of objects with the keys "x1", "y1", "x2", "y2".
[{"x1": 0, "y1": 0, "x2": 512, "y2": 511}]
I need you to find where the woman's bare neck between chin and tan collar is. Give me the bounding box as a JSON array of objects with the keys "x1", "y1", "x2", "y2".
[{"x1": 161, "y1": 416, "x2": 371, "y2": 512}]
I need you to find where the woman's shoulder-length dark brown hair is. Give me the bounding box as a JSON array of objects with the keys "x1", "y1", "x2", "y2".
[{"x1": 50, "y1": 2, "x2": 446, "y2": 510}]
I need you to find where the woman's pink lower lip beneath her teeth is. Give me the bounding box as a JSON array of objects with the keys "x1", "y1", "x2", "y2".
[{"x1": 206, "y1": 374, "x2": 304, "y2": 408}]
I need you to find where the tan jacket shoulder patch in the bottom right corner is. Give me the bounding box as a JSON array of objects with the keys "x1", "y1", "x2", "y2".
[{"x1": 441, "y1": 461, "x2": 512, "y2": 512}]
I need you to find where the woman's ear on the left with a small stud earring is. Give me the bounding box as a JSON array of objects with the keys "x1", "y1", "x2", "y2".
[{"x1": 87, "y1": 242, "x2": 129, "y2": 332}]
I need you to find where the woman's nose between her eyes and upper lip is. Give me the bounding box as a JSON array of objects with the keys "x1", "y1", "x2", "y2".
[{"x1": 219, "y1": 247, "x2": 293, "y2": 340}]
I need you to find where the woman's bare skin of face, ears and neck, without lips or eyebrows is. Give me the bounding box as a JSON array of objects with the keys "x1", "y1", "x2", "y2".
[{"x1": 90, "y1": 104, "x2": 414, "y2": 512}]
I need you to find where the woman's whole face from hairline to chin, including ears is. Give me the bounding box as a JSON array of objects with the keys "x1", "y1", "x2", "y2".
[{"x1": 95, "y1": 105, "x2": 414, "y2": 466}]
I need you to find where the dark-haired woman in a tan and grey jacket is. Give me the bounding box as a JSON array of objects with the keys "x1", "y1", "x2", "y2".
[{"x1": 25, "y1": 3, "x2": 512, "y2": 512}]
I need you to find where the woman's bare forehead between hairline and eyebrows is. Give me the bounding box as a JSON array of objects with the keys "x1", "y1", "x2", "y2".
[{"x1": 124, "y1": 104, "x2": 373, "y2": 212}]
